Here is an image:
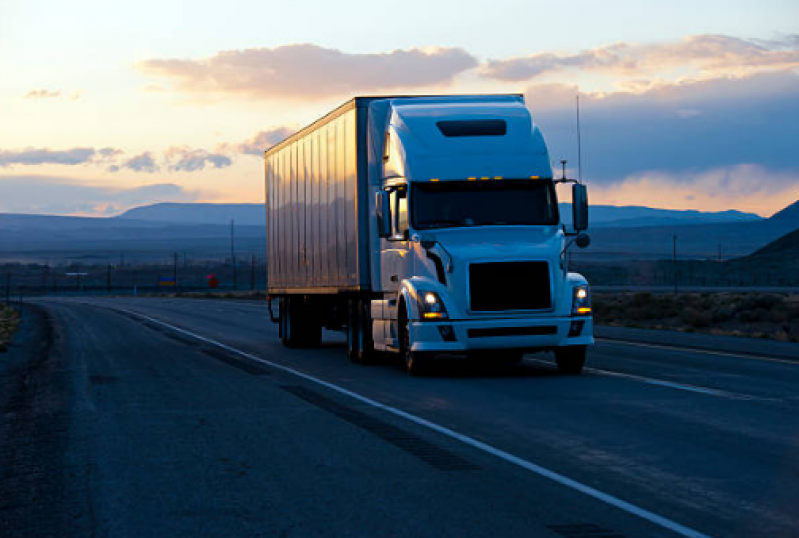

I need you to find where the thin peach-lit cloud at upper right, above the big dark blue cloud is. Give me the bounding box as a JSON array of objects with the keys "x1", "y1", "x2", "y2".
[{"x1": 482, "y1": 34, "x2": 799, "y2": 82}]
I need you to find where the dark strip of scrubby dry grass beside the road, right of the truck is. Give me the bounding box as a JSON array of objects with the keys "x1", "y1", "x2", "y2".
[{"x1": 593, "y1": 292, "x2": 799, "y2": 342}]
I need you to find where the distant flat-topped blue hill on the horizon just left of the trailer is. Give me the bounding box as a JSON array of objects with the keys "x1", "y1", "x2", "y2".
[{"x1": 116, "y1": 203, "x2": 266, "y2": 226}]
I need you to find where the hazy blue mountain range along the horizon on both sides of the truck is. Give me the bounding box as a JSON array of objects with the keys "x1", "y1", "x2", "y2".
[{"x1": 0, "y1": 198, "x2": 799, "y2": 263}]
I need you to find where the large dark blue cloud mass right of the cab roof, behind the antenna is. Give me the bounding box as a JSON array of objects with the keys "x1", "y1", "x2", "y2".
[{"x1": 525, "y1": 72, "x2": 799, "y2": 180}]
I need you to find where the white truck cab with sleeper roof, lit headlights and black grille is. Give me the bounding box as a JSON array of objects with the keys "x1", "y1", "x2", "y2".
[{"x1": 370, "y1": 96, "x2": 593, "y2": 373}]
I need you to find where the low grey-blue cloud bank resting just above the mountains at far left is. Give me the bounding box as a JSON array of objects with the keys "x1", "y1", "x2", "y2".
[{"x1": 0, "y1": 175, "x2": 209, "y2": 216}]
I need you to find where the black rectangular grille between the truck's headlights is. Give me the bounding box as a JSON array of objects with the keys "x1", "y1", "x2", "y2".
[{"x1": 469, "y1": 262, "x2": 552, "y2": 312}]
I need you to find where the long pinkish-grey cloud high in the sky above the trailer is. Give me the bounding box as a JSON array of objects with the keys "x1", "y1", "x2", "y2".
[{"x1": 139, "y1": 44, "x2": 478, "y2": 100}]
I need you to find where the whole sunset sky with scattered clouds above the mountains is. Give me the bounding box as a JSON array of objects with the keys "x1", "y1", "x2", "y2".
[{"x1": 0, "y1": 0, "x2": 799, "y2": 216}]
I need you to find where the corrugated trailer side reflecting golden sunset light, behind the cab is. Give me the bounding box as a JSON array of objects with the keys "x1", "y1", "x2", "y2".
[{"x1": 265, "y1": 99, "x2": 370, "y2": 294}]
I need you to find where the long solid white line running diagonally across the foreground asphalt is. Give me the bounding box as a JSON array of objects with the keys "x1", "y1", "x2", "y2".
[{"x1": 110, "y1": 307, "x2": 710, "y2": 538}]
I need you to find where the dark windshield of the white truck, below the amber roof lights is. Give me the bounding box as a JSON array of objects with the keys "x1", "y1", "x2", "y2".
[{"x1": 410, "y1": 180, "x2": 558, "y2": 230}]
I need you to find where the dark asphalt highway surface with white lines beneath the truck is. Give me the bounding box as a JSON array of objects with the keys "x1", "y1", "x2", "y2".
[{"x1": 0, "y1": 298, "x2": 799, "y2": 538}]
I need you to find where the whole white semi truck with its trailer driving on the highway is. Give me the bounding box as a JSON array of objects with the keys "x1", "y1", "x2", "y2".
[{"x1": 265, "y1": 95, "x2": 594, "y2": 374}]
